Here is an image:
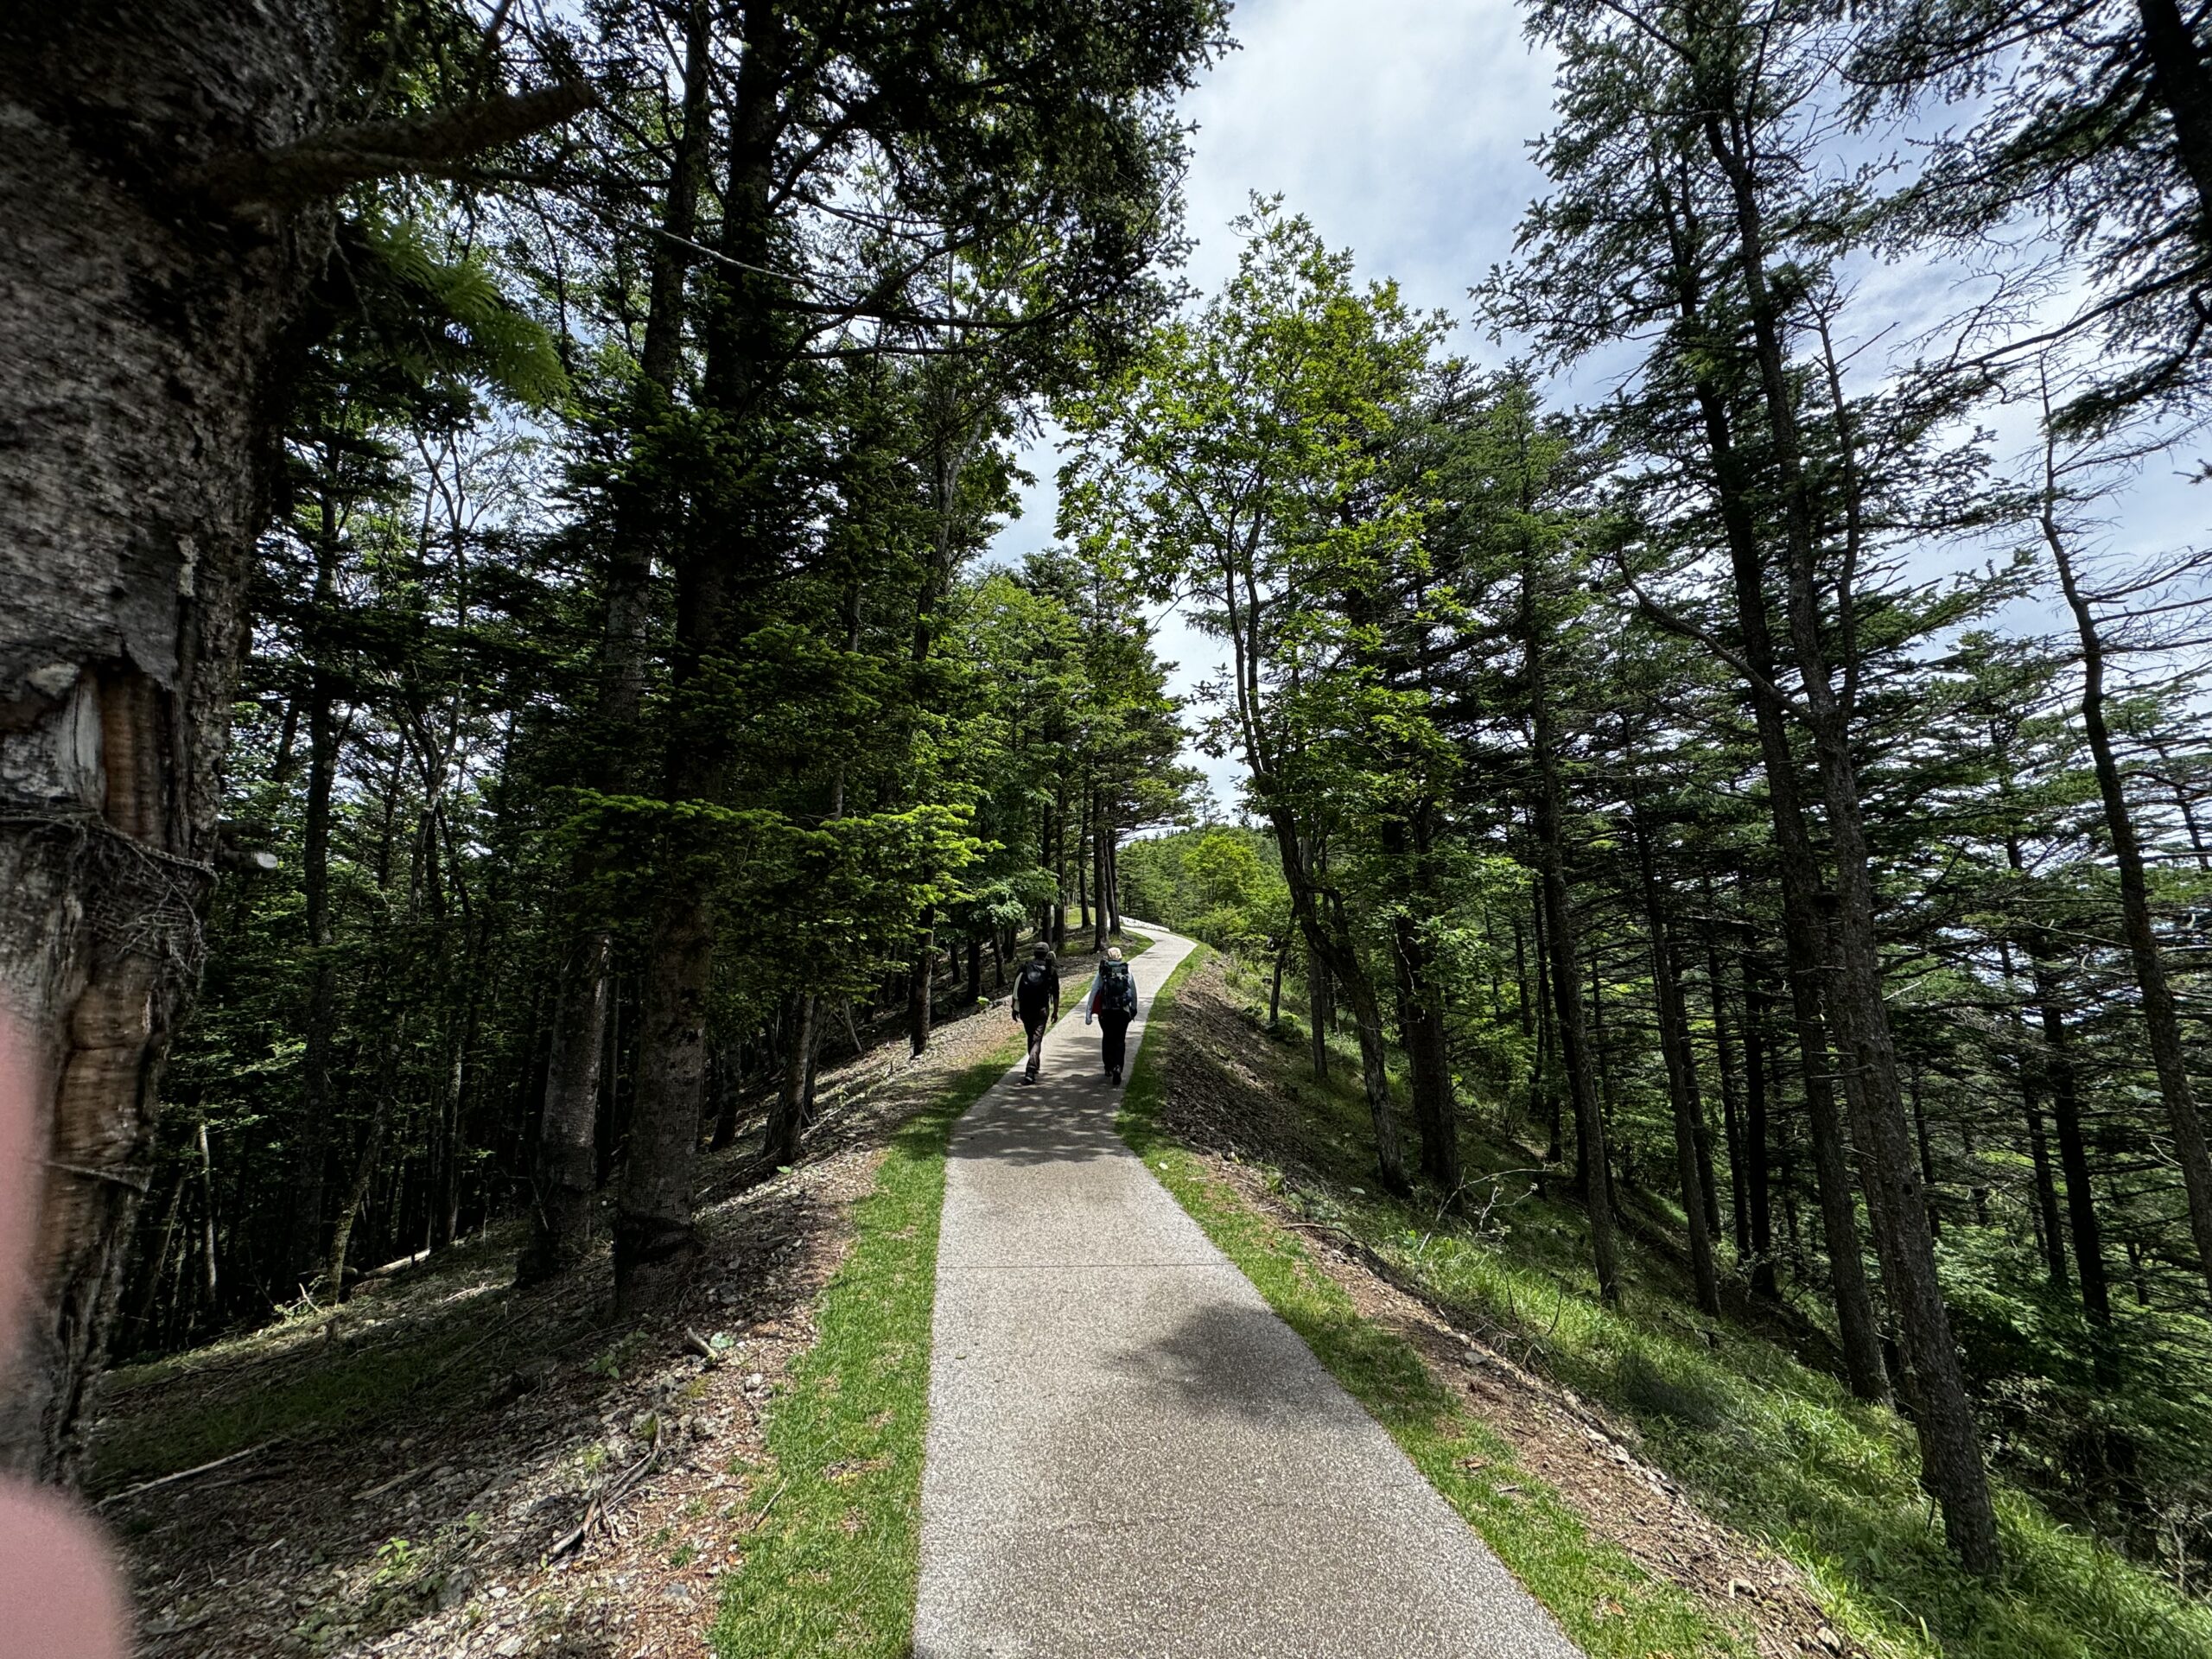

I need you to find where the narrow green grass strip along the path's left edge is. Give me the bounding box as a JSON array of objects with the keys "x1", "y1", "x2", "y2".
[{"x1": 710, "y1": 1033, "x2": 1022, "y2": 1659}]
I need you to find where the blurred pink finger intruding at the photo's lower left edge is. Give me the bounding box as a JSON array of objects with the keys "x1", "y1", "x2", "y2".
[{"x1": 0, "y1": 1007, "x2": 128, "y2": 1659}]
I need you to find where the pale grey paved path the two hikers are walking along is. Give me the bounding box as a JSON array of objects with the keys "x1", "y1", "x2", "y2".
[{"x1": 913, "y1": 925, "x2": 1580, "y2": 1659}]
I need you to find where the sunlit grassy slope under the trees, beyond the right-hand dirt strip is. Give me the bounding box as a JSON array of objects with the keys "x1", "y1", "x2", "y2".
[{"x1": 1133, "y1": 955, "x2": 2212, "y2": 1659}]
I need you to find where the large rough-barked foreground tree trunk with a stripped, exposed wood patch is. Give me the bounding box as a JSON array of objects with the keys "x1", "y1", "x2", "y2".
[{"x1": 0, "y1": 0, "x2": 339, "y2": 1480}]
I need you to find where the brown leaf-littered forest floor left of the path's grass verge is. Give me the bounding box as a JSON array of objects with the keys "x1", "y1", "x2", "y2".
[{"x1": 93, "y1": 931, "x2": 1132, "y2": 1659}]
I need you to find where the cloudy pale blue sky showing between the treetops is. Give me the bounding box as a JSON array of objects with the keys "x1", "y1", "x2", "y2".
[{"x1": 991, "y1": 0, "x2": 2205, "y2": 817}]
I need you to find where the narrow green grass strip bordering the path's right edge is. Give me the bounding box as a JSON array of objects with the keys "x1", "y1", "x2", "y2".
[{"x1": 1119, "y1": 947, "x2": 1752, "y2": 1659}]
